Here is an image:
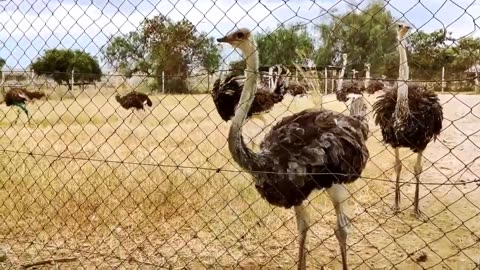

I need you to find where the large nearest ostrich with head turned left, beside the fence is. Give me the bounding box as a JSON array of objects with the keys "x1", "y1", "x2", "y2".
[{"x1": 217, "y1": 28, "x2": 369, "y2": 270}]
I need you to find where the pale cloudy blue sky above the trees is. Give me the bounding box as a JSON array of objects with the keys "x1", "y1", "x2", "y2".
[{"x1": 0, "y1": 0, "x2": 480, "y2": 69}]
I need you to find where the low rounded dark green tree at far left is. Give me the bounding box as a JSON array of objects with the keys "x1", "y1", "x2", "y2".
[{"x1": 31, "y1": 49, "x2": 102, "y2": 90}]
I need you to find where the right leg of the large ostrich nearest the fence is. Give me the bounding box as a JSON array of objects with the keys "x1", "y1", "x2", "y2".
[{"x1": 327, "y1": 184, "x2": 350, "y2": 270}]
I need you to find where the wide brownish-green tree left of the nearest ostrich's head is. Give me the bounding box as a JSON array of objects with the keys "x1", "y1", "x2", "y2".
[{"x1": 102, "y1": 16, "x2": 220, "y2": 92}]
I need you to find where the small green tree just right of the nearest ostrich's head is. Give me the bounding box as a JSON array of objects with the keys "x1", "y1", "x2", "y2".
[{"x1": 255, "y1": 24, "x2": 314, "y2": 66}]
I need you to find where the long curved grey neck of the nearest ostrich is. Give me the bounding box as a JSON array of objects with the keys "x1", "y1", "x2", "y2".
[{"x1": 228, "y1": 42, "x2": 258, "y2": 170}]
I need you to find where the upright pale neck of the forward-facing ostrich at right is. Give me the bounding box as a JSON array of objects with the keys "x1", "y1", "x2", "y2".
[{"x1": 395, "y1": 37, "x2": 409, "y2": 119}]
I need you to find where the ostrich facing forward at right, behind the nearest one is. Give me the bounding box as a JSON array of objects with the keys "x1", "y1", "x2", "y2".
[{"x1": 373, "y1": 24, "x2": 443, "y2": 219}]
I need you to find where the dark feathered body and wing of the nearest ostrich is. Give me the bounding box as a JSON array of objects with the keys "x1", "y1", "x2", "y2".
[{"x1": 254, "y1": 110, "x2": 369, "y2": 208}]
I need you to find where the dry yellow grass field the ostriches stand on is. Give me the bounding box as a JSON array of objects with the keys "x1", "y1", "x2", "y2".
[{"x1": 0, "y1": 85, "x2": 480, "y2": 269}]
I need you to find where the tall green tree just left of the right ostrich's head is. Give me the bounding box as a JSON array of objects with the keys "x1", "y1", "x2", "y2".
[{"x1": 316, "y1": 2, "x2": 398, "y2": 76}]
